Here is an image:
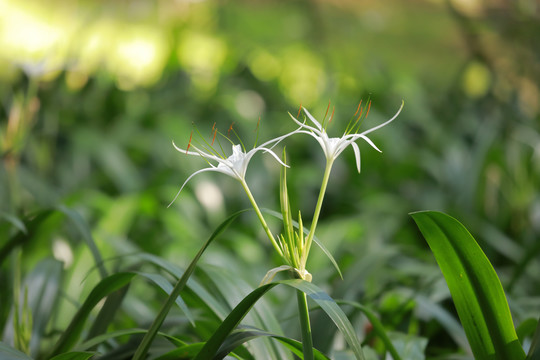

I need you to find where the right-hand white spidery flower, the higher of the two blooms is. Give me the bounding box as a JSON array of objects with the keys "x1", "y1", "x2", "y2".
[{"x1": 289, "y1": 102, "x2": 404, "y2": 172}]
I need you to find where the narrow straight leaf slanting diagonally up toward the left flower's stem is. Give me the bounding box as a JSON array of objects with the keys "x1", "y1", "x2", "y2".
[{"x1": 133, "y1": 210, "x2": 247, "y2": 360}]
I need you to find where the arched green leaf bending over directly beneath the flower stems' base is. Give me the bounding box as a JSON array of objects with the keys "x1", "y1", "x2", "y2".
[{"x1": 195, "y1": 279, "x2": 364, "y2": 360}]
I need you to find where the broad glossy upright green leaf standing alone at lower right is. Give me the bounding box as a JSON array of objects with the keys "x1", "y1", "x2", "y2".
[{"x1": 411, "y1": 211, "x2": 525, "y2": 360}]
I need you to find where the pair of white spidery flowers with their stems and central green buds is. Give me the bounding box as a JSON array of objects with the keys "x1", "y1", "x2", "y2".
[{"x1": 169, "y1": 102, "x2": 403, "y2": 282}]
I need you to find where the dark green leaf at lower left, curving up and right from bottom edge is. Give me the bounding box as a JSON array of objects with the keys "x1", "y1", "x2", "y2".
[{"x1": 51, "y1": 272, "x2": 135, "y2": 356}]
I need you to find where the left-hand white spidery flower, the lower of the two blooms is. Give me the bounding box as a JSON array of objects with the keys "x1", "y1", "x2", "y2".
[{"x1": 169, "y1": 129, "x2": 300, "y2": 206}]
